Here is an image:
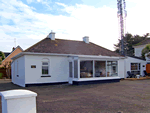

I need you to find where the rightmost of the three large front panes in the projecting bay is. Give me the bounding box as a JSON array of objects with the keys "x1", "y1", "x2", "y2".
[{"x1": 107, "y1": 61, "x2": 118, "y2": 77}]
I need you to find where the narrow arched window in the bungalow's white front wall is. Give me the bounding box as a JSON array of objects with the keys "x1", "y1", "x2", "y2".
[{"x1": 42, "y1": 59, "x2": 49, "y2": 75}]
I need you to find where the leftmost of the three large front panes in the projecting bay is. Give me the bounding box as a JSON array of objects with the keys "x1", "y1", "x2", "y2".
[{"x1": 80, "y1": 61, "x2": 93, "y2": 78}]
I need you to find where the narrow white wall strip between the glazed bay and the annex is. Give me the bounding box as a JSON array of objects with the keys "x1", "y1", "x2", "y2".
[{"x1": 118, "y1": 59, "x2": 125, "y2": 78}]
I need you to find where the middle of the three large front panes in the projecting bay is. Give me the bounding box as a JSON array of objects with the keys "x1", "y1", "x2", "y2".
[{"x1": 95, "y1": 61, "x2": 106, "y2": 77}]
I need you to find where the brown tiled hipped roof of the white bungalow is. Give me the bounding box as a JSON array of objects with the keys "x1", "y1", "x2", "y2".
[{"x1": 24, "y1": 38, "x2": 120, "y2": 56}]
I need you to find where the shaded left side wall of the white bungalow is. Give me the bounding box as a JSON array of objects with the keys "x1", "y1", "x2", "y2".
[{"x1": 11, "y1": 56, "x2": 25, "y2": 87}]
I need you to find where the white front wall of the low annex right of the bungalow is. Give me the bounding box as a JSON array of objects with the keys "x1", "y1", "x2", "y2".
[{"x1": 125, "y1": 57, "x2": 146, "y2": 77}]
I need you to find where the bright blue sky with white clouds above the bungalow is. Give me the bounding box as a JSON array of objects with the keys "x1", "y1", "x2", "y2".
[{"x1": 0, "y1": 0, "x2": 150, "y2": 52}]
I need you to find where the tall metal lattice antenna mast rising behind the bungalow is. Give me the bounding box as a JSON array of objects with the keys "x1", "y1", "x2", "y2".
[{"x1": 117, "y1": 0, "x2": 127, "y2": 56}]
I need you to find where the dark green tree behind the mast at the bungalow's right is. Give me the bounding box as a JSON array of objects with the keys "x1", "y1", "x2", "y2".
[{"x1": 114, "y1": 33, "x2": 149, "y2": 56}]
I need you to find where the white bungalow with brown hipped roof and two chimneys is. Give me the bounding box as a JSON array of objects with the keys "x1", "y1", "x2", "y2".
[{"x1": 11, "y1": 32, "x2": 125, "y2": 87}]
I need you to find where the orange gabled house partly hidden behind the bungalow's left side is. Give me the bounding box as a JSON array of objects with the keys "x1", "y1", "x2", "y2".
[{"x1": 0, "y1": 46, "x2": 23, "y2": 67}]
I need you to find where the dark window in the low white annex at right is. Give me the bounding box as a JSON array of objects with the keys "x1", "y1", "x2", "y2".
[{"x1": 131, "y1": 63, "x2": 140, "y2": 75}]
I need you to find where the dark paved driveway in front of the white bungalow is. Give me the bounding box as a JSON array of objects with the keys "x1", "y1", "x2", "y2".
[{"x1": 0, "y1": 80, "x2": 150, "y2": 113}]
